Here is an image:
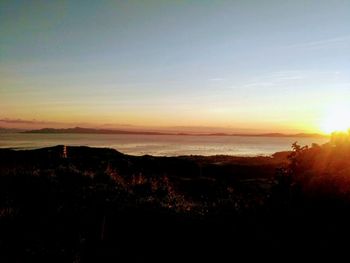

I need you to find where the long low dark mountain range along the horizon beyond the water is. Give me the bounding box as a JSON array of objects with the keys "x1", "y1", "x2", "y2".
[{"x1": 22, "y1": 127, "x2": 327, "y2": 138}]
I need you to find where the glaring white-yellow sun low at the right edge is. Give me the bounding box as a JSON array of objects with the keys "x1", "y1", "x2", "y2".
[{"x1": 321, "y1": 104, "x2": 350, "y2": 133}]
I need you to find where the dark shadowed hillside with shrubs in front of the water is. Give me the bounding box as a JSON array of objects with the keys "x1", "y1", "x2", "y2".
[{"x1": 0, "y1": 146, "x2": 350, "y2": 262}]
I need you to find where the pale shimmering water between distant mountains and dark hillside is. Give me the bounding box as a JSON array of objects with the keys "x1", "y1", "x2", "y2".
[{"x1": 0, "y1": 133, "x2": 327, "y2": 156}]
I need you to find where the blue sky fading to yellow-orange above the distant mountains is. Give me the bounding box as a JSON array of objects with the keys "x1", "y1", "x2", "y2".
[{"x1": 0, "y1": 0, "x2": 350, "y2": 132}]
